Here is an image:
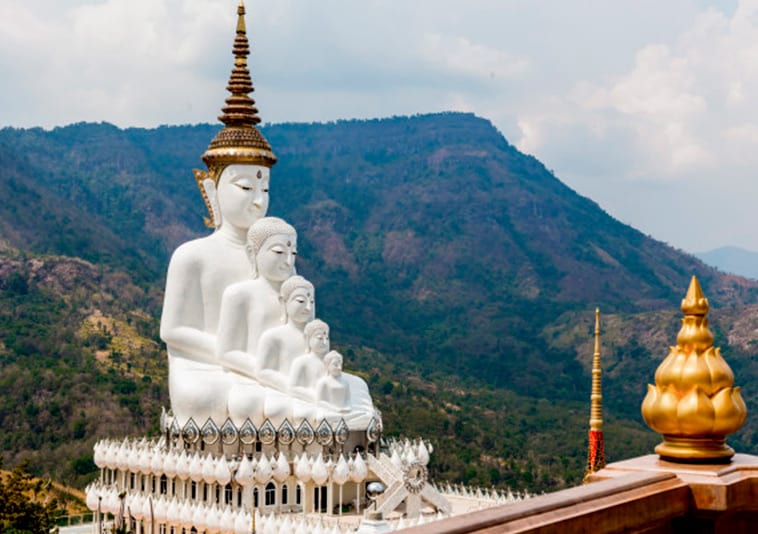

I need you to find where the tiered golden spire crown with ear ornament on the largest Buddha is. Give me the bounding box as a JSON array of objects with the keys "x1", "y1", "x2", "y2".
[{"x1": 195, "y1": 0, "x2": 276, "y2": 226}]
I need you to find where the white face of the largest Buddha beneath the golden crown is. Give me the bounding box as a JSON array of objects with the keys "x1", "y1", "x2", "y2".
[{"x1": 216, "y1": 165, "x2": 269, "y2": 230}]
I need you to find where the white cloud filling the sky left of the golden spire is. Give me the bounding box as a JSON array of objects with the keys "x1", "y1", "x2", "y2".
[{"x1": 0, "y1": 0, "x2": 234, "y2": 126}]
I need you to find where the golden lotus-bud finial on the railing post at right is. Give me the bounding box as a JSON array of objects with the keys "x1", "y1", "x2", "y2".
[{"x1": 642, "y1": 276, "x2": 747, "y2": 463}]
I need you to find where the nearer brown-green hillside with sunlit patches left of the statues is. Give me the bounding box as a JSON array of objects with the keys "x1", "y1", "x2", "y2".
[{"x1": 0, "y1": 245, "x2": 167, "y2": 486}]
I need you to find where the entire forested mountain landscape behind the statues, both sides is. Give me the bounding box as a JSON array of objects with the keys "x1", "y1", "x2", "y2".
[{"x1": 0, "y1": 113, "x2": 758, "y2": 489}]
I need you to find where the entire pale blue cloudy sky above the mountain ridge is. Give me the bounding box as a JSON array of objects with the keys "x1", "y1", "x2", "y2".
[{"x1": 0, "y1": 0, "x2": 758, "y2": 252}]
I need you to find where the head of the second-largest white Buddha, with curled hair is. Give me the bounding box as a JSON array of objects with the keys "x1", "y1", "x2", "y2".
[{"x1": 246, "y1": 217, "x2": 297, "y2": 282}]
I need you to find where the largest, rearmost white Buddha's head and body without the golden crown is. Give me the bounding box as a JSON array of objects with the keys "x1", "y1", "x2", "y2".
[{"x1": 160, "y1": 165, "x2": 269, "y2": 424}]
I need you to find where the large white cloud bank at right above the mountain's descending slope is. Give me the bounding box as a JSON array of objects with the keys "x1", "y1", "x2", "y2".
[{"x1": 504, "y1": 0, "x2": 758, "y2": 250}]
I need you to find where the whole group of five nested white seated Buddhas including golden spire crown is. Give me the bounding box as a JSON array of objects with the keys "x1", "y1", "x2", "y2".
[{"x1": 161, "y1": 1, "x2": 382, "y2": 430}]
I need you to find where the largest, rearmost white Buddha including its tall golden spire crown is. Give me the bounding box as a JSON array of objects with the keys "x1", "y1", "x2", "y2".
[{"x1": 160, "y1": 1, "x2": 276, "y2": 424}]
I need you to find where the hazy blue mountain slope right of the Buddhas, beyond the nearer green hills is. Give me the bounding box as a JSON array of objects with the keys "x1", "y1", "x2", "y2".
[{"x1": 266, "y1": 114, "x2": 758, "y2": 399}]
